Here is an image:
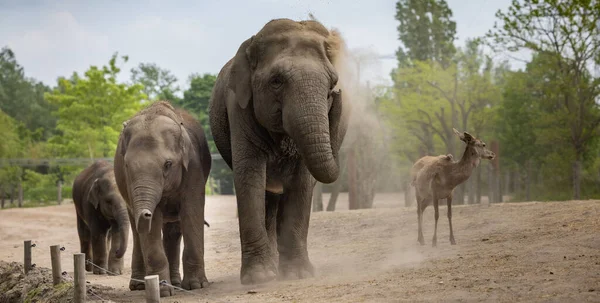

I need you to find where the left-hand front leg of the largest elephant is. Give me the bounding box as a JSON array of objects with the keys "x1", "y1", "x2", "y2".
[{"x1": 232, "y1": 146, "x2": 277, "y2": 284}]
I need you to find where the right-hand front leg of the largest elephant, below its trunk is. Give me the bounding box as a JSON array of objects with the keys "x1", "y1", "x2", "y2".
[{"x1": 277, "y1": 177, "x2": 314, "y2": 279}]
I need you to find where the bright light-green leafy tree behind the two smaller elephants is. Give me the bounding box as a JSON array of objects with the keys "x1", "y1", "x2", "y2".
[{"x1": 46, "y1": 53, "x2": 147, "y2": 159}]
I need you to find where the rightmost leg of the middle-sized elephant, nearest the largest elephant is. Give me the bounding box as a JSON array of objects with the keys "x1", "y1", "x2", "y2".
[{"x1": 179, "y1": 186, "x2": 208, "y2": 290}]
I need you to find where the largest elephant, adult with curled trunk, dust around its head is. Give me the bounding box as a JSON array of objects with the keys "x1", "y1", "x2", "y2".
[{"x1": 209, "y1": 19, "x2": 349, "y2": 284}]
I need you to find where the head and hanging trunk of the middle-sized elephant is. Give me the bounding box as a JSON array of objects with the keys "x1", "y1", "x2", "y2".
[{"x1": 118, "y1": 102, "x2": 194, "y2": 233}]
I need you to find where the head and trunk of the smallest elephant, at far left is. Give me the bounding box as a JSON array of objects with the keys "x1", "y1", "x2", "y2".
[{"x1": 86, "y1": 174, "x2": 130, "y2": 258}]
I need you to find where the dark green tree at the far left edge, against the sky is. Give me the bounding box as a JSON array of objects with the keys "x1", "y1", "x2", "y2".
[{"x1": 0, "y1": 47, "x2": 56, "y2": 140}]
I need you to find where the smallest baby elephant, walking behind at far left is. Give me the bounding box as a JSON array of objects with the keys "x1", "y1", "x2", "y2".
[{"x1": 73, "y1": 161, "x2": 130, "y2": 275}]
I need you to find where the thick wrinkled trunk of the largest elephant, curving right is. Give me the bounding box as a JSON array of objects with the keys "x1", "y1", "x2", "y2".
[{"x1": 283, "y1": 78, "x2": 339, "y2": 184}]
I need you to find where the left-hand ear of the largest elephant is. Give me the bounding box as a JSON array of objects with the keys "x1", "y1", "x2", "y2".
[{"x1": 228, "y1": 36, "x2": 254, "y2": 108}]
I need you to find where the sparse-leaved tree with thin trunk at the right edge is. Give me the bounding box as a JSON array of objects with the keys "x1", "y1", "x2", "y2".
[{"x1": 487, "y1": 0, "x2": 600, "y2": 199}]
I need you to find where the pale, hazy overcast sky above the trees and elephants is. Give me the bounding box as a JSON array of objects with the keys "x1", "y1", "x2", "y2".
[{"x1": 0, "y1": 0, "x2": 511, "y2": 91}]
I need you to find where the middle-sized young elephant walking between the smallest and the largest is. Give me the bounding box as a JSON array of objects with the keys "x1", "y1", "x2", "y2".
[{"x1": 115, "y1": 101, "x2": 211, "y2": 297}]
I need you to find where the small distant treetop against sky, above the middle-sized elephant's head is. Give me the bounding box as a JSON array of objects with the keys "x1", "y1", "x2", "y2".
[{"x1": 131, "y1": 63, "x2": 179, "y2": 102}]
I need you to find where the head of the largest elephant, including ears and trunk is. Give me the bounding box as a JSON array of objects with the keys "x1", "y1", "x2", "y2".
[{"x1": 229, "y1": 19, "x2": 345, "y2": 183}]
